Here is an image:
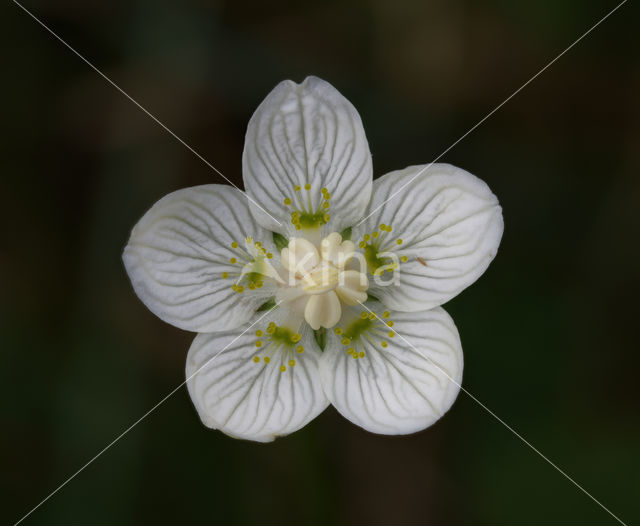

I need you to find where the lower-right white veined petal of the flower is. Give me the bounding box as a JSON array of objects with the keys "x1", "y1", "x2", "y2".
[{"x1": 320, "y1": 303, "x2": 463, "y2": 435}]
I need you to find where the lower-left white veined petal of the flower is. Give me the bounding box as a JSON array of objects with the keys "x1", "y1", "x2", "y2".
[{"x1": 186, "y1": 308, "x2": 328, "y2": 442}]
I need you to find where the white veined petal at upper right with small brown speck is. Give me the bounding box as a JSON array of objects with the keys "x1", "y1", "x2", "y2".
[{"x1": 352, "y1": 164, "x2": 504, "y2": 311}]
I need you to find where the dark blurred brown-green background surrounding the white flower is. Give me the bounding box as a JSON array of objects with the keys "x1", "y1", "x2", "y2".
[{"x1": 0, "y1": 0, "x2": 640, "y2": 525}]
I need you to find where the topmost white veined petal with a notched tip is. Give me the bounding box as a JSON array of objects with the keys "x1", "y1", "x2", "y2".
[{"x1": 243, "y1": 77, "x2": 372, "y2": 235}]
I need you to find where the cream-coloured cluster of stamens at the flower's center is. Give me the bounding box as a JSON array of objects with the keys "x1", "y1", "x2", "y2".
[{"x1": 280, "y1": 232, "x2": 369, "y2": 330}]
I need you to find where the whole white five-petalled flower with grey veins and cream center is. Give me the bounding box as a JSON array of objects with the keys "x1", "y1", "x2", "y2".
[{"x1": 123, "y1": 77, "x2": 503, "y2": 442}]
